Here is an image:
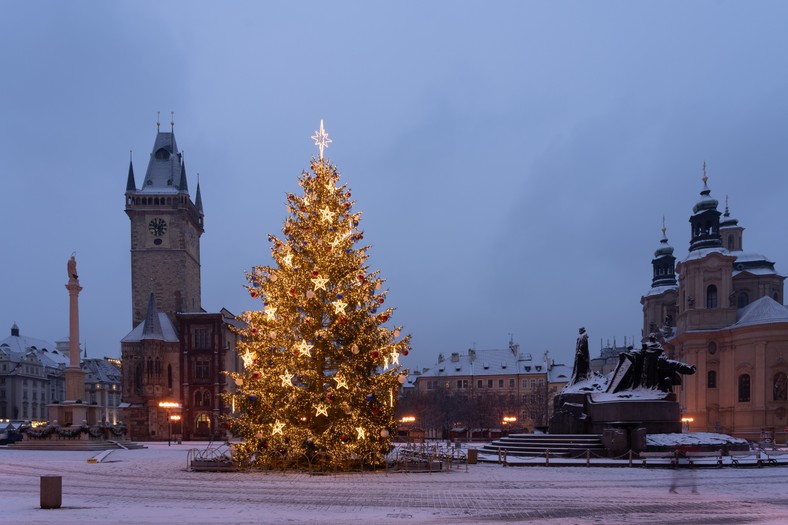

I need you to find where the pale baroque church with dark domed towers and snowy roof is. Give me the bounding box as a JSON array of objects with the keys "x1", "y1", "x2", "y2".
[{"x1": 641, "y1": 171, "x2": 788, "y2": 441}]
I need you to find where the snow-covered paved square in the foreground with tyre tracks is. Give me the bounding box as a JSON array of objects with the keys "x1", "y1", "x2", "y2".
[{"x1": 0, "y1": 443, "x2": 788, "y2": 525}]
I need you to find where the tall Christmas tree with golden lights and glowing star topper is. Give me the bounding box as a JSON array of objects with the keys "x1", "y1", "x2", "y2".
[{"x1": 229, "y1": 121, "x2": 410, "y2": 469}]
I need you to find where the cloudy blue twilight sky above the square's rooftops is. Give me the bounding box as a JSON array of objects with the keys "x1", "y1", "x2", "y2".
[{"x1": 0, "y1": 0, "x2": 788, "y2": 367}]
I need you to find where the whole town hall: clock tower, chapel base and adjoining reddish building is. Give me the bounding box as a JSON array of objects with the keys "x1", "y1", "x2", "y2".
[{"x1": 121, "y1": 125, "x2": 241, "y2": 440}]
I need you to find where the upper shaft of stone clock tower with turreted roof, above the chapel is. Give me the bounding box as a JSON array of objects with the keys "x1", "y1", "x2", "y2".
[{"x1": 126, "y1": 124, "x2": 204, "y2": 327}]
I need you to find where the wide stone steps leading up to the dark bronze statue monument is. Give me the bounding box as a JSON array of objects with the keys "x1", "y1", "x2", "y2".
[{"x1": 479, "y1": 434, "x2": 607, "y2": 458}]
